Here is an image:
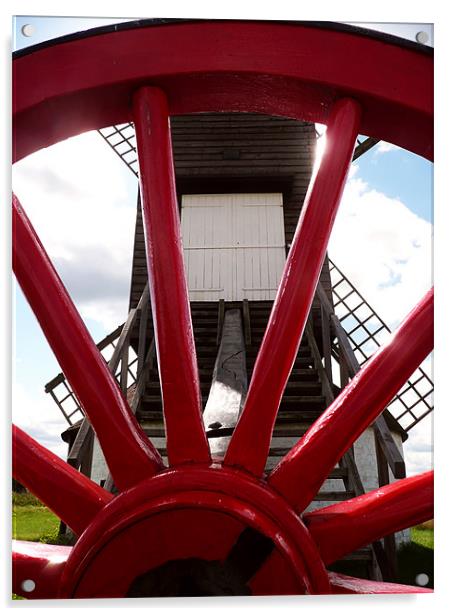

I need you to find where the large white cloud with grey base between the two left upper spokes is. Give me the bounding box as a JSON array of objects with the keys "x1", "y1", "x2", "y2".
[{"x1": 13, "y1": 132, "x2": 137, "y2": 331}]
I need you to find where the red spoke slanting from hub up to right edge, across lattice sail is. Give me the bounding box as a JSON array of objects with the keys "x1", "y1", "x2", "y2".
[{"x1": 269, "y1": 289, "x2": 433, "y2": 512}]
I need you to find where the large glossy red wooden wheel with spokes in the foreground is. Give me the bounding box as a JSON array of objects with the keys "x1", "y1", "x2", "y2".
[{"x1": 13, "y1": 21, "x2": 433, "y2": 598}]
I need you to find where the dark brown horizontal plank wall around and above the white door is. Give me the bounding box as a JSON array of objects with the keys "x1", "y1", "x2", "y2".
[{"x1": 130, "y1": 113, "x2": 331, "y2": 336}]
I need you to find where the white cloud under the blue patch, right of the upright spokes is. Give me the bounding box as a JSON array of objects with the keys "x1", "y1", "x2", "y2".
[{"x1": 329, "y1": 164, "x2": 432, "y2": 329}]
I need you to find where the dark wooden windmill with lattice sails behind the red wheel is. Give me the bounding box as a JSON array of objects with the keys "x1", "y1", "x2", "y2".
[{"x1": 46, "y1": 113, "x2": 431, "y2": 577}]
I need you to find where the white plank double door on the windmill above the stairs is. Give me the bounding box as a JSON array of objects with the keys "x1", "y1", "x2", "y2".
[{"x1": 181, "y1": 193, "x2": 286, "y2": 301}]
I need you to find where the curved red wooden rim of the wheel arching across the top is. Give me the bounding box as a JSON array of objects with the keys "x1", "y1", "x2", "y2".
[{"x1": 13, "y1": 20, "x2": 433, "y2": 160}]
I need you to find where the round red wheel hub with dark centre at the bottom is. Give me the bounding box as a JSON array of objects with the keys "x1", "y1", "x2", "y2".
[{"x1": 60, "y1": 467, "x2": 329, "y2": 597}]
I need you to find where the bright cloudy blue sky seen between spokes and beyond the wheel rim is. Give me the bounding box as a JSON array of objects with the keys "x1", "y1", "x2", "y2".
[{"x1": 13, "y1": 17, "x2": 433, "y2": 471}]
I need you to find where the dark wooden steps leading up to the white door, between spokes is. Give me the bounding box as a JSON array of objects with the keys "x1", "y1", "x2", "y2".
[{"x1": 137, "y1": 301, "x2": 374, "y2": 577}]
